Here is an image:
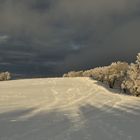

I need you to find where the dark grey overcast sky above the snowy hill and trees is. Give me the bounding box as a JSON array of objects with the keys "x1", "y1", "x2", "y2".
[{"x1": 0, "y1": 0, "x2": 140, "y2": 76}]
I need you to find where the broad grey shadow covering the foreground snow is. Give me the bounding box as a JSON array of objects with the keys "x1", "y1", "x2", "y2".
[{"x1": 0, "y1": 104, "x2": 140, "y2": 140}]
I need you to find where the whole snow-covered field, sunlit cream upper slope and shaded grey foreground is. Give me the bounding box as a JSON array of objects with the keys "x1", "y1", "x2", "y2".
[{"x1": 0, "y1": 78, "x2": 140, "y2": 140}]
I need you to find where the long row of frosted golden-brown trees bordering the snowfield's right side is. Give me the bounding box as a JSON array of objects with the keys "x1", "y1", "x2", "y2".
[{"x1": 63, "y1": 53, "x2": 140, "y2": 96}]
